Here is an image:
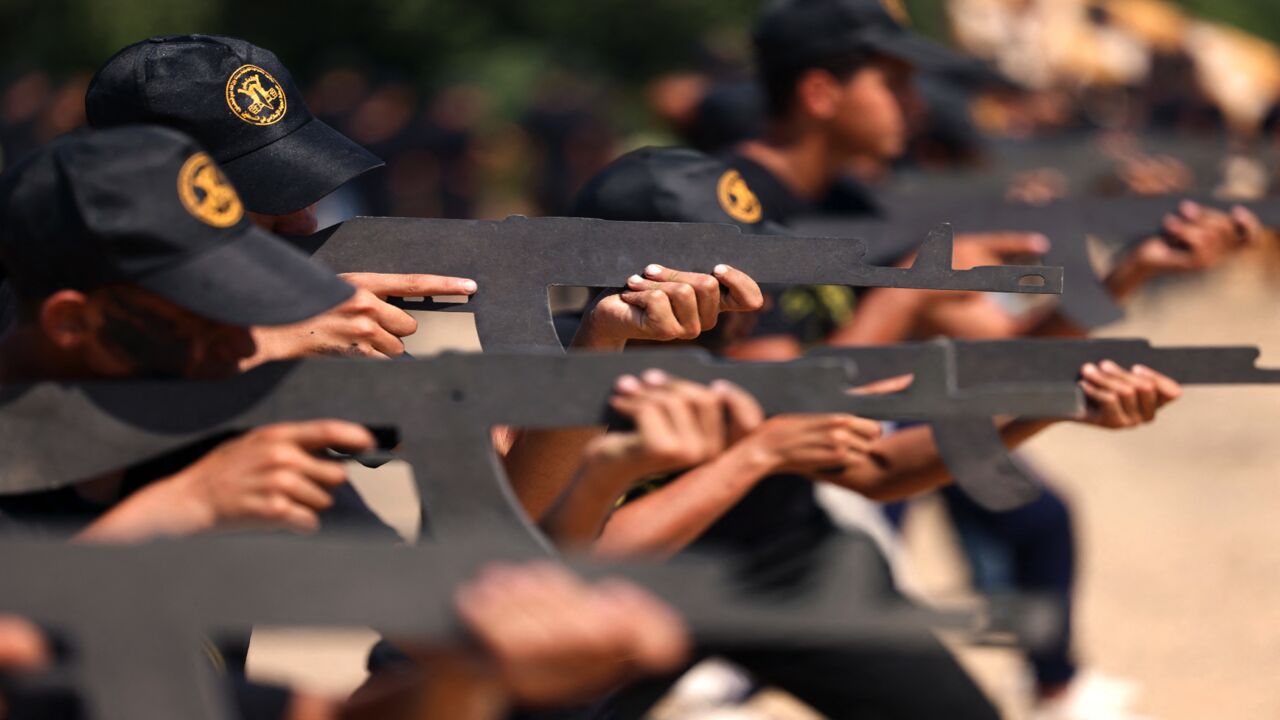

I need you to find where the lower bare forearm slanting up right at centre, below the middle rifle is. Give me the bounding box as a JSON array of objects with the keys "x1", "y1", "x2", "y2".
[{"x1": 595, "y1": 443, "x2": 772, "y2": 557}]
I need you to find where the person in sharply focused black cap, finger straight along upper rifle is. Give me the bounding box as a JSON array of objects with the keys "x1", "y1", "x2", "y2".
[{"x1": 86, "y1": 35, "x2": 763, "y2": 518}]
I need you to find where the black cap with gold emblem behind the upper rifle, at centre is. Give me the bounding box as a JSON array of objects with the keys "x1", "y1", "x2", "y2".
[{"x1": 573, "y1": 147, "x2": 765, "y2": 232}]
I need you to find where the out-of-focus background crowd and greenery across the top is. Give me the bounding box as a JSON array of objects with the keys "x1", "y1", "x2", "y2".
[{"x1": 0, "y1": 0, "x2": 1280, "y2": 218}]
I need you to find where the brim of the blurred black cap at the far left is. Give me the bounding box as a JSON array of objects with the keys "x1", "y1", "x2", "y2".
[{"x1": 134, "y1": 225, "x2": 355, "y2": 327}]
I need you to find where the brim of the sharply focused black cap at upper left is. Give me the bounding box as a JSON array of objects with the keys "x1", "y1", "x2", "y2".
[{"x1": 219, "y1": 118, "x2": 383, "y2": 215}]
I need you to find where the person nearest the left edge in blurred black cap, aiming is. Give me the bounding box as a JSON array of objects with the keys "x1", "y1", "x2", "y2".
[{"x1": 0, "y1": 127, "x2": 394, "y2": 536}]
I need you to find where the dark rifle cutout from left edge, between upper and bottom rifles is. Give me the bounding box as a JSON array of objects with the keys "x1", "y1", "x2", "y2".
[{"x1": 0, "y1": 345, "x2": 1082, "y2": 532}]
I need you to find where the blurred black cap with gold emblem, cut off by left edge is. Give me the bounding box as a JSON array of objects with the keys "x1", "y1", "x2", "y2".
[{"x1": 0, "y1": 126, "x2": 355, "y2": 327}]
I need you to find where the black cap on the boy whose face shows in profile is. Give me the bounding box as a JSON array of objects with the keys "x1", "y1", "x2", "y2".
[{"x1": 753, "y1": 0, "x2": 970, "y2": 70}]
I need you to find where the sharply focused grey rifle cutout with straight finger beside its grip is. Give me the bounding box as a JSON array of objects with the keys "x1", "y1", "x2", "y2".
[{"x1": 294, "y1": 217, "x2": 1062, "y2": 350}]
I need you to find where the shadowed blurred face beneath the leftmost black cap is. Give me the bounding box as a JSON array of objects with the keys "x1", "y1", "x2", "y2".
[{"x1": 40, "y1": 286, "x2": 256, "y2": 379}]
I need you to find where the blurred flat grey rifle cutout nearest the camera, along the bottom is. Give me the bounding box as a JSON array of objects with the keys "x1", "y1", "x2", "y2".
[{"x1": 0, "y1": 528, "x2": 1059, "y2": 720}]
